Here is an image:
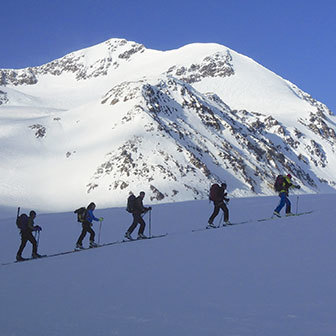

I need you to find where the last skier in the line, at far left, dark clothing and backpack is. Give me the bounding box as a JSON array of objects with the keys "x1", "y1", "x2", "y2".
[{"x1": 16, "y1": 210, "x2": 42, "y2": 261}]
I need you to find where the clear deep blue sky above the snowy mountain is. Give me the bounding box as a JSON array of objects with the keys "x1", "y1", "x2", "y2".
[{"x1": 0, "y1": 0, "x2": 336, "y2": 113}]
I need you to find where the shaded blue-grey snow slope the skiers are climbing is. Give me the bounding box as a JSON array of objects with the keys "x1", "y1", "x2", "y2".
[{"x1": 0, "y1": 194, "x2": 336, "y2": 336}]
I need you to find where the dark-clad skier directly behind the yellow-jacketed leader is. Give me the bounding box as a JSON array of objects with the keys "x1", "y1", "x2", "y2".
[{"x1": 208, "y1": 183, "x2": 231, "y2": 227}]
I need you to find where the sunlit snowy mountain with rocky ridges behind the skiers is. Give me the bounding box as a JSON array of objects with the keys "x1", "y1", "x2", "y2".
[{"x1": 0, "y1": 39, "x2": 336, "y2": 210}]
